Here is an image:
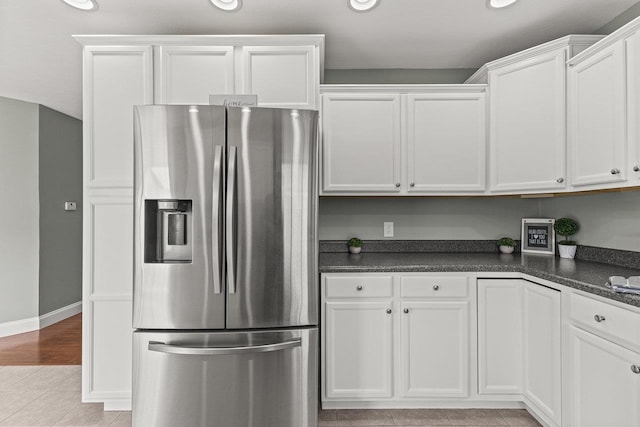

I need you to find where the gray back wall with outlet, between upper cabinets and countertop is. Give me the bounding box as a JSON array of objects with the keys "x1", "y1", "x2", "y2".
[{"x1": 319, "y1": 197, "x2": 540, "y2": 240}]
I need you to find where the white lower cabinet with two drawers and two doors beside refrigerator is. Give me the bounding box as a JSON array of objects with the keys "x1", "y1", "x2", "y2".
[{"x1": 322, "y1": 274, "x2": 475, "y2": 407}]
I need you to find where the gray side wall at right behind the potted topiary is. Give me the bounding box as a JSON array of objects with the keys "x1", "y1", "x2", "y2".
[{"x1": 542, "y1": 191, "x2": 640, "y2": 252}]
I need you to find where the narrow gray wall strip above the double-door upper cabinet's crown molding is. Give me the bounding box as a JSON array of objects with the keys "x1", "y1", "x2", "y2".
[{"x1": 323, "y1": 68, "x2": 476, "y2": 84}]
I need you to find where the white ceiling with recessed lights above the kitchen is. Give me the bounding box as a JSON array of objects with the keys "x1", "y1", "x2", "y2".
[{"x1": 0, "y1": 0, "x2": 637, "y2": 118}]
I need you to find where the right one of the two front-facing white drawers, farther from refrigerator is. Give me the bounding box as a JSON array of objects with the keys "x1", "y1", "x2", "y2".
[{"x1": 400, "y1": 276, "x2": 469, "y2": 298}]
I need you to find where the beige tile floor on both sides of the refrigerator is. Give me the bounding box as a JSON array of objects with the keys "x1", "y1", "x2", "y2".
[{"x1": 0, "y1": 366, "x2": 540, "y2": 427}]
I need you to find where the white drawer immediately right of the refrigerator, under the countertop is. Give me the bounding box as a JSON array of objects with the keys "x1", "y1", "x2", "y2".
[{"x1": 325, "y1": 275, "x2": 393, "y2": 298}]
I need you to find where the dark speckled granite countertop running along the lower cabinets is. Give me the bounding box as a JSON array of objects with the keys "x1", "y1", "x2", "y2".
[{"x1": 319, "y1": 252, "x2": 640, "y2": 307}]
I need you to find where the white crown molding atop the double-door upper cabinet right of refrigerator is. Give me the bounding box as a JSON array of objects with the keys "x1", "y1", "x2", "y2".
[{"x1": 320, "y1": 84, "x2": 487, "y2": 94}]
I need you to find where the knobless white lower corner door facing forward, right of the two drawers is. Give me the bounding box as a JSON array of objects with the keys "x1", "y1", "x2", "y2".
[{"x1": 478, "y1": 279, "x2": 524, "y2": 394}]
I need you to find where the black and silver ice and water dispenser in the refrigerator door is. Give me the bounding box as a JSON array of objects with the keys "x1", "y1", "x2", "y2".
[{"x1": 144, "y1": 200, "x2": 193, "y2": 263}]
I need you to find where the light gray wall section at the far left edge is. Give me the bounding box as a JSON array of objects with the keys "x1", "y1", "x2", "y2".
[{"x1": 0, "y1": 97, "x2": 38, "y2": 323}]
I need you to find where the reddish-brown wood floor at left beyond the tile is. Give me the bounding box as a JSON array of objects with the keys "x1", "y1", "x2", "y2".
[{"x1": 0, "y1": 313, "x2": 82, "y2": 366}]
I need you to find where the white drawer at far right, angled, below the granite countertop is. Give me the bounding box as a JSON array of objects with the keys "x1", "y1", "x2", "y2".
[{"x1": 571, "y1": 294, "x2": 640, "y2": 347}]
